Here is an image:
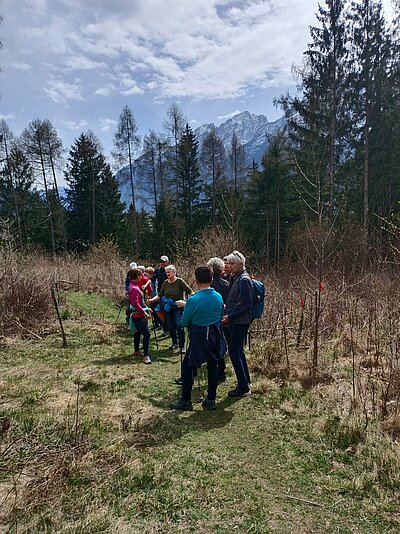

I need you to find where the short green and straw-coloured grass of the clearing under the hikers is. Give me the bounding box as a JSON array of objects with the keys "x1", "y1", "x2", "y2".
[{"x1": 0, "y1": 293, "x2": 400, "y2": 534}]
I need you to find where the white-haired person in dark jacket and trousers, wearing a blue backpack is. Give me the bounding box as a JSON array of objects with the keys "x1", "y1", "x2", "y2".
[{"x1": 222, "y1": 250, "x2": 253, "y2": 397}]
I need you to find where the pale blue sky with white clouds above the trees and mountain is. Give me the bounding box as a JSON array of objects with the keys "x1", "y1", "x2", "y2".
[{"x1": 0, "y1": 0, "x2": 390, "y2": 162}]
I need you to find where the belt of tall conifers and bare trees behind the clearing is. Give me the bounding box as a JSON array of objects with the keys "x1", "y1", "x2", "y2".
[{"x1": 0, "y1": 0, "x2": 400, "y2": 269}]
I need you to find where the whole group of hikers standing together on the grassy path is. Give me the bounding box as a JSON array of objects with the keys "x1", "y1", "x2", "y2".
[{"x1": 125, "y1": 250, "x2": 265, "y2": 410}]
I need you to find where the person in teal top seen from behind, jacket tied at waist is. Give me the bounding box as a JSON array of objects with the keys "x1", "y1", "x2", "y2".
[{"x1": 170, "y1": 265, "x2": 226, "y2": 410}]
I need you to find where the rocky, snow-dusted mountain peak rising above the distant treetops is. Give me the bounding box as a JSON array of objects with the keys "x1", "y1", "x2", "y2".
[{"x1": 194, "y1": 111, "x2": 285, "y2": 164}]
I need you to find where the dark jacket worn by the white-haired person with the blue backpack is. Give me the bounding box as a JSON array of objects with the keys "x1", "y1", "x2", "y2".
[{"x1": 225, "y1": 269, "x2": 253, "y2": 324}]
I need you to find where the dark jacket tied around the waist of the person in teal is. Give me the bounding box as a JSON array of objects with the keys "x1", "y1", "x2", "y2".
[{"x1": 187, "y1": 321, "x2": 227, "y2": 367}]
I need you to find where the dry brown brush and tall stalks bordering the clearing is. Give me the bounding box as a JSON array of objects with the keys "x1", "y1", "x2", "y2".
[{"x1": 0, "y1": 237, "x2": 400, "y2": 433}]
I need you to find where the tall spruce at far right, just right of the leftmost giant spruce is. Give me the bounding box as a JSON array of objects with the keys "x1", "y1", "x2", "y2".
[{"x1": 349, "y1": 0, "x2": 391, "y2": 247}]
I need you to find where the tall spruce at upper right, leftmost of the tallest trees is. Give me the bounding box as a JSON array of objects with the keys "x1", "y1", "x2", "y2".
[{"x1": 278, "y1": 0, "x2": 348, "y2": 221}]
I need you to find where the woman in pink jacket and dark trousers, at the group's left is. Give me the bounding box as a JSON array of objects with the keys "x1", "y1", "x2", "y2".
[{"x1": 128, "y1": 269, "x2": 151, "y2": 363}]
